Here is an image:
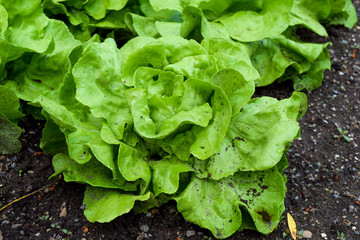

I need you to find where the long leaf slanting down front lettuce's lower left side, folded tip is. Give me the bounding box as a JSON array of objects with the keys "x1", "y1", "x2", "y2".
[{"x1": 35, "y1": 79, "x2": 121, "y2": 184}]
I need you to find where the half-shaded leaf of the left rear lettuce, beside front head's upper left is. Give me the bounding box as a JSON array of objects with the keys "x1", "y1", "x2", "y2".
[{"x1": 7, "y1": 20, "x2": 80, "y2": 101}]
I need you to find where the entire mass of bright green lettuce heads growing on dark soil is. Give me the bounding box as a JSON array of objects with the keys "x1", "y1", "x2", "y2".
[{"x1": 0, "y1": 0, "x2": 356, "y2": 238}]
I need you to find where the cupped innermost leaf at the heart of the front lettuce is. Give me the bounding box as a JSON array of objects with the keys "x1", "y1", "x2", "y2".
[{"x1": 127, "y1": 69, "x2": 212, "y2": 138}]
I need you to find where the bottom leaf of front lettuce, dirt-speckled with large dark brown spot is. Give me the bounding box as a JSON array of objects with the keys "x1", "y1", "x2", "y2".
[{"x1": 173, "y1": 168, "x2": 286, "y2": 238}]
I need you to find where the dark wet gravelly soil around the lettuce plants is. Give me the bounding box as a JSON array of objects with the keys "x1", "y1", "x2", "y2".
[{"x1": 0, "y1": 1, "x2": 360, "y2": 240}]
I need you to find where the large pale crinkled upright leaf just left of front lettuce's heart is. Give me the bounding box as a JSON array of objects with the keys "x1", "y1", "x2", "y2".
[{"x1": 73, "y1": 39, "x2": 132, "y2": 140}]
